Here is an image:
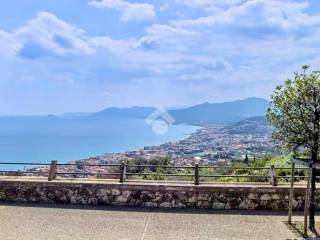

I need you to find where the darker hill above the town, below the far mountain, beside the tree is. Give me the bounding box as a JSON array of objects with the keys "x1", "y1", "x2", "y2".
[{"x1": 225, "y1": 116, "x2": 271, "y2": 134}]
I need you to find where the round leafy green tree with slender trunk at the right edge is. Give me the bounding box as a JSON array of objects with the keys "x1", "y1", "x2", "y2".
[{"x1": 267, "y1": 65, "x2": 320, "y2": 230}]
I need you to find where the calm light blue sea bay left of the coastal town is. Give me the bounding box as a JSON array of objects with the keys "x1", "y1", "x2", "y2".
[{"x1": 0, "y1": 117, "x2": 198, "y2": 169}]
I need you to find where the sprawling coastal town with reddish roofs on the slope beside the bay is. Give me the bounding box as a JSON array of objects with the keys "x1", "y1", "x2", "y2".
[{"x1": 48, "y1": 121, "x2": 278, "y2": 174}]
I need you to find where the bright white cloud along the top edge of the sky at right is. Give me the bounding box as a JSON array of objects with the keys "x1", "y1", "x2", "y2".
[{"x1": 174, "y1": 0, "x2": 320, "y2": 31}]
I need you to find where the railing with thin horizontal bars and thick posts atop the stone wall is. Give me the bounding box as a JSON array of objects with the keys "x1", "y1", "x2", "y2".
[{"x1": 0, "y1": 160, "x2": 307, "y2": 186}]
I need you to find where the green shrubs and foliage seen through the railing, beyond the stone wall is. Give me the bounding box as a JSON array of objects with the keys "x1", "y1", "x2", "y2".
[{"x1": 124, "y1": 155, "x2": 305, "y2": 182}]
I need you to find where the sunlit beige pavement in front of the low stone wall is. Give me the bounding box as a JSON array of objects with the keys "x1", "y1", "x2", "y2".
[{"x1": 0, "y1": 204, "x2": 297, "y2": 240}]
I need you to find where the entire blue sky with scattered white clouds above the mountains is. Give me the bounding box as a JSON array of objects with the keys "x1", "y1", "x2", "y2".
[{"x1": 0, "y1": 0, "x2": 320, "y2": 115}]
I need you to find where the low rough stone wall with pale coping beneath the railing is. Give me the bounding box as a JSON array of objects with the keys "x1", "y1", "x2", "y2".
[{"x1": 0, "y1": 179, "x2": 320, "y2": 210}]
